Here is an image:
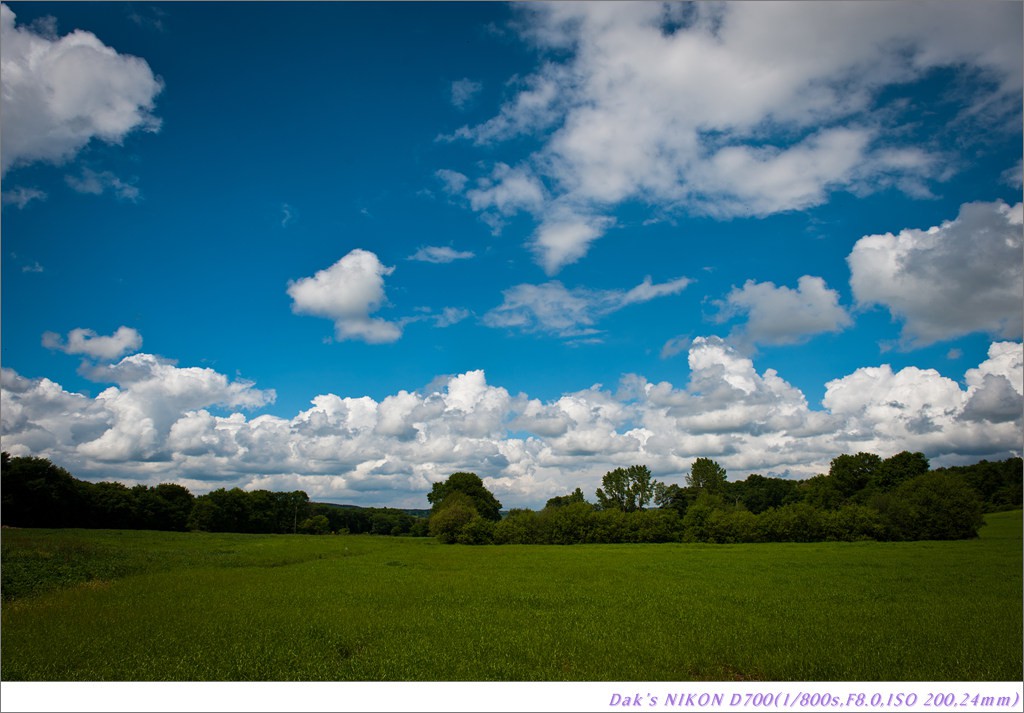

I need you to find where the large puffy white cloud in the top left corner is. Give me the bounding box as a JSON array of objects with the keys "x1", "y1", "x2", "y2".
[{"x1": 0, "y1": 5, "x2": 162, "y2": 173}]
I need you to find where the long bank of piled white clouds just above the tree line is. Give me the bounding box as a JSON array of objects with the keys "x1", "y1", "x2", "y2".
[{"x1": 0, "y1": 337, "x2": 1024, "y2": 507}]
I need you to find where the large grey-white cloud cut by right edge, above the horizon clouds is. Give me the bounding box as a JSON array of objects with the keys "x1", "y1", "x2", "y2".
[{"x1": 847, "y1": 201, "x2": 1024, "y2": 348}]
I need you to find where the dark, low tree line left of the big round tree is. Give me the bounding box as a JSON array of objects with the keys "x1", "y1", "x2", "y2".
[{"x1": 0, "y1": 453, "x2": 427, "y2": 537}]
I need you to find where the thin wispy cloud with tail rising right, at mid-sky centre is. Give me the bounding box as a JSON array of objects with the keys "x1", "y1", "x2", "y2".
[{"x1": 483, "y1": 277, "x2": 691, "y2": 338}]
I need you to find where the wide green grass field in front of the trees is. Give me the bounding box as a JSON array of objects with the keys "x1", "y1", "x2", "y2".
[{"x1": 0, "y1": 511, "x2": 1024, "y2": 681}]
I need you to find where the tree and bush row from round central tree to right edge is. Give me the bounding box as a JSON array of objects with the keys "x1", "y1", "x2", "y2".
[{"x1": 427, "y1": 451, "x2": 1024, "y2": 544}]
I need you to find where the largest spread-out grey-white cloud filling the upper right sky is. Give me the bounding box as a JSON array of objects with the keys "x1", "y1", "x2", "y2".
[{"x1": 443, "y1": 2, "x2": 1022, "y2": 275}]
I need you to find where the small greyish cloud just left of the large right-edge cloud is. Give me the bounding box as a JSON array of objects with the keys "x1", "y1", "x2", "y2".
[{"x1": 720, "y1": 275, "x2": 852, "y2": 344}]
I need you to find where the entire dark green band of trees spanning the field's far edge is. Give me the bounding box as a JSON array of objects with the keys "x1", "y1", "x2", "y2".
[{"x1": 0, "y1": 451, "x2": 1024, "y2": 545}]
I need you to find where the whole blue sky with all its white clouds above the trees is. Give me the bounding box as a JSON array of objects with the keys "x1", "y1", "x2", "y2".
[{"x1": 0, "y1": 0, "x2": 1024, "y2": 508}]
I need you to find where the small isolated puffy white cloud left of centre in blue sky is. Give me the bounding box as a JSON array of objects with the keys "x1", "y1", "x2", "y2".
[{"x1": 288, "y1": 249, "x2": 401, "y2": 344}]
